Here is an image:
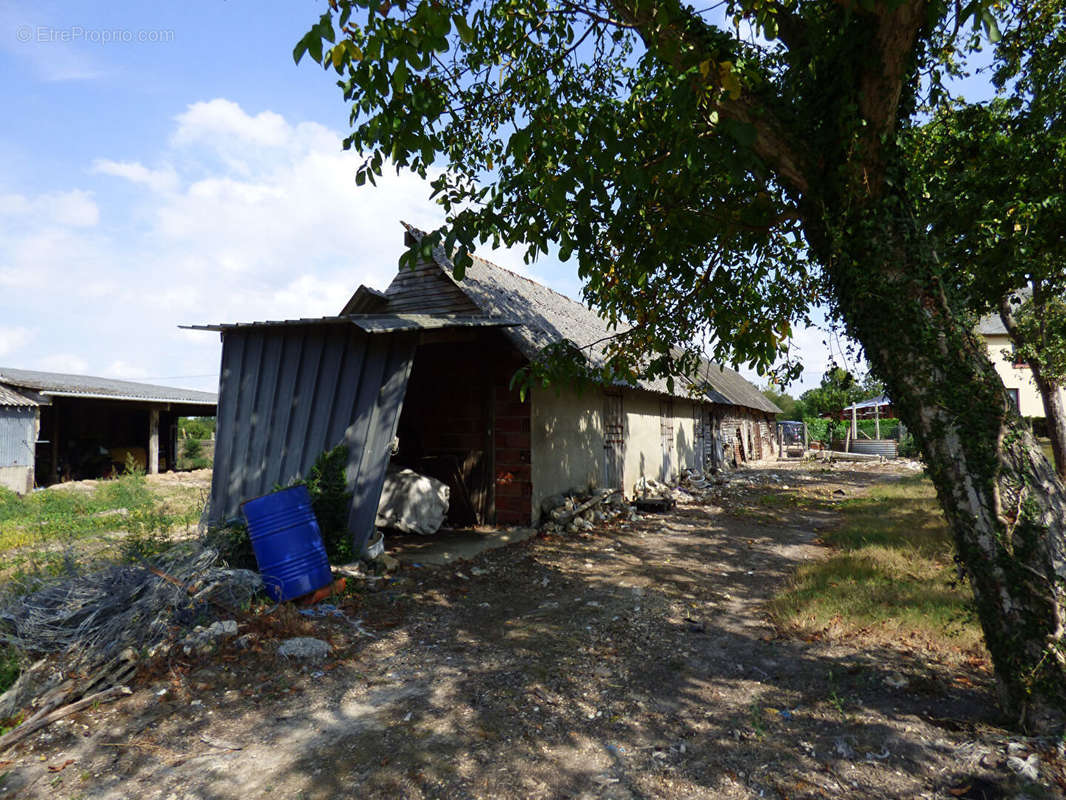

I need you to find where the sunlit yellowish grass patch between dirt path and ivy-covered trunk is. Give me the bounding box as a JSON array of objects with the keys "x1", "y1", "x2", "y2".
[{"x1": 771, "y1": 476, "x2": 982, "y2": 655}]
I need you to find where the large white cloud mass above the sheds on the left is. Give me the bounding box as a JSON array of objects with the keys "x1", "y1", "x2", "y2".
[{"x1": 0, "y1": 100, "x2": 475, "y2": 389}]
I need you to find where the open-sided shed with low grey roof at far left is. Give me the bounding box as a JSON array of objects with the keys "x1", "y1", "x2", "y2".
[{"x1": 0, "y1": 367, "x2": 216, "y2": 493}]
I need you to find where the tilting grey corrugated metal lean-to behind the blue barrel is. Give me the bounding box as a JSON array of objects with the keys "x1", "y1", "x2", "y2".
[{"x1": 206, "y1": 316, "x2": 513, "y2": 551}]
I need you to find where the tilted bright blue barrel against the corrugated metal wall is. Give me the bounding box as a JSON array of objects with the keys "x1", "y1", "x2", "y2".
[{"x1": 241, "y1": 486, "x2": 333, "y2": 602}]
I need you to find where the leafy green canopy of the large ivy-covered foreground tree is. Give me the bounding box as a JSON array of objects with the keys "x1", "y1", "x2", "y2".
[{"x1": 293, "y1": 0, "x2": 1014, "y2": 388}]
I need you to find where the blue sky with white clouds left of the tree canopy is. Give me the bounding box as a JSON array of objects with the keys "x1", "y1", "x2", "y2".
[{"x1": 0, "y1": 0, "x2": 997, "y2": 391}]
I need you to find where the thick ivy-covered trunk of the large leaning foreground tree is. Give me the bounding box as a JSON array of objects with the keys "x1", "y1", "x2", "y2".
[{"x1": 808, "y1": 198, "x2": 1066, "y2": 731}]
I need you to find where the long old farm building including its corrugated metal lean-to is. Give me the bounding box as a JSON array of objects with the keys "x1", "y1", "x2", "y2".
[{"x1": 200, "y1": 229, "x2": 779, "y2": 542}]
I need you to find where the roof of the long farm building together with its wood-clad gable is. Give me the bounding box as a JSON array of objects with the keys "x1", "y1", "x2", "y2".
[{"x1": 375, "y1": 225, "x2": 780, "y2": 414}]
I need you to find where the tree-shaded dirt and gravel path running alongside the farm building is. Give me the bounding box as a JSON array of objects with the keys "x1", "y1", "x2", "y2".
[{"x1": 0, "y1": 462, "x2": 1056, "y2": 800}]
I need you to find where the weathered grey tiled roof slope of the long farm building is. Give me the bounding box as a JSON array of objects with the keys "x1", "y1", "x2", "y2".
[{"x1": 396, "y1": 226, "x2": 780, "y2": 414}]
